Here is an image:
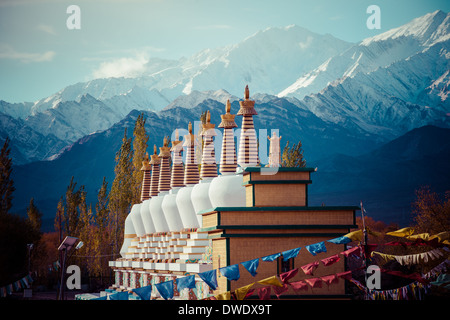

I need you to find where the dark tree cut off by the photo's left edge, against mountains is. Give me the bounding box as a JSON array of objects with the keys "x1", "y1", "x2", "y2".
[{"x1": 0, "y1": 137, "x2": 15, "y2": 215}]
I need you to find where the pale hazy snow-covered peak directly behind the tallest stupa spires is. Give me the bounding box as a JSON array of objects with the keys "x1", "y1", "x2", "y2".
[{"x1": 22, "y1": 26, "x2": 351, "y2": 114}]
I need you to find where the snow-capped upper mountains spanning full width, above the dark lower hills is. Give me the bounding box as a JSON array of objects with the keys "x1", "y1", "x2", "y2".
[{"x1": 0, "y1": 11, "x2": 450, "y2": 166}]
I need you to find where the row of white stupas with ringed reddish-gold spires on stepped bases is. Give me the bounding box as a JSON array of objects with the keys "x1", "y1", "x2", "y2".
[{"x1": 114, "y1": 87, "x2": 268, "y2": 272}]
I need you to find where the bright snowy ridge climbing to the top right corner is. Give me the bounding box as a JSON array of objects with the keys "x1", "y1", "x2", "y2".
[{"x1": 278, "y1": 10, "x2": 450, "y2": 99}]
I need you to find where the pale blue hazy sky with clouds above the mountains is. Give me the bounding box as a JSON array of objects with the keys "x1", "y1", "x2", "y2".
[{"x1": 0, "y1": 0, "x2": 450, "y2": 102}]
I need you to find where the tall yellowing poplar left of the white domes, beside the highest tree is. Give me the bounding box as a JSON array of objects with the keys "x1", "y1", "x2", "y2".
[{"x1": 108, "y1": 129, "x2": 133, "y2": 253}]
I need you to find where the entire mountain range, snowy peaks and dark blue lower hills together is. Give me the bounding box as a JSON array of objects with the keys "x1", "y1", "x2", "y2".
[{"x1": 0, "y1": 11, "x2": 450, "y2": 230}]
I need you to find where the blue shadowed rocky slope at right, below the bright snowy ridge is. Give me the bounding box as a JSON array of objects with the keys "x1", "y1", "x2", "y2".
[{"x1": 300, "y1": 40, "x2": 450, "y2": 139}]
